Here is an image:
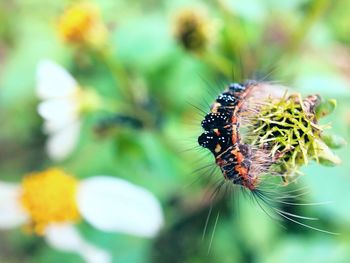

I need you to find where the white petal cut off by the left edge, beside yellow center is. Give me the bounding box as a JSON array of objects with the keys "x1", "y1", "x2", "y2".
[{"x1": 0, "y1": 182, "x2": 28, "y2": 229}]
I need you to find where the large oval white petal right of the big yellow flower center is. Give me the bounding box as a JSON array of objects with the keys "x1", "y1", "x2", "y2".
[{"x1": 78, "y1": 176, "x2": 163, "y2": 237}]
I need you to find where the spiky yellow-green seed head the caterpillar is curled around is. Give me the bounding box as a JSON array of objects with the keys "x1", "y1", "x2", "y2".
[{"x1": 247, "y1": 94, "x2": 340, "y2": 180}]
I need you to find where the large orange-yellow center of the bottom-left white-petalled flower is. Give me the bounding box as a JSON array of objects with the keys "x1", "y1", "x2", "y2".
[{"x1": 21, "y1": 168, "x2": 80, "y2": 234}]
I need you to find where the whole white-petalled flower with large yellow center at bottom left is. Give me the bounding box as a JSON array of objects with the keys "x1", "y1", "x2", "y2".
[{"x1": 0, "y1": 168, "x2": 163, "y2": 263}]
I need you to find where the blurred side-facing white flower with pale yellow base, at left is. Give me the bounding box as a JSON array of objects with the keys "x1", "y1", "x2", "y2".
[{"x1": 37, "y1": 60, "x2": 100, "y2": 161}]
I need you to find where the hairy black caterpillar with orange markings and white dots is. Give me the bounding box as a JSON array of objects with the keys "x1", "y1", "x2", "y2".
[{"x1": 198, "y1": 81, "x2": 272, "y2": 190}]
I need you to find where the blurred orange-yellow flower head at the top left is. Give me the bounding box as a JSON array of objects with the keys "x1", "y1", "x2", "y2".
[{"x1": 58, "y1": 3, "x2": 106, "y2": 44}]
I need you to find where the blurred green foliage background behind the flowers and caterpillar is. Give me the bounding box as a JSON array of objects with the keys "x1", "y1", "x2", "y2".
[{"x1": 0, "y1": 0, "x2": 350, "y2": 263}]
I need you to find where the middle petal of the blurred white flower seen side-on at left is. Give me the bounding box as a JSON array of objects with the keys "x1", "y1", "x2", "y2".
[{"x1": 38, "y1": 98, "x2": 79, "y2": 126}]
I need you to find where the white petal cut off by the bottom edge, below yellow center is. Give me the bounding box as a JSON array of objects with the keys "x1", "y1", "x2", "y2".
[{"x1": 45, "y1": 224, "x2": 112, "y2": 263}]
